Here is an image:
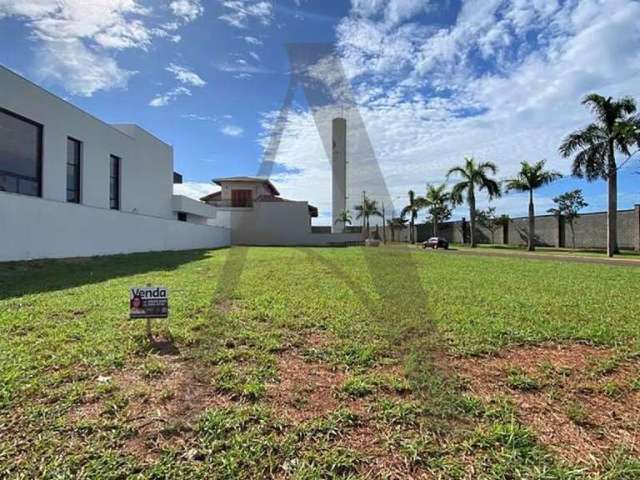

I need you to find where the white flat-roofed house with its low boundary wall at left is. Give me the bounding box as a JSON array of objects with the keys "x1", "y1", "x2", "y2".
[{"x1": 0, "y1": 67, "x2": 230, "y2": 261}]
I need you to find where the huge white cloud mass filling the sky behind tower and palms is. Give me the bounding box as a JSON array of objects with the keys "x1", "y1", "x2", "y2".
[{"x1": 262, "y1": 0, "x2": 640, "y2": 220}]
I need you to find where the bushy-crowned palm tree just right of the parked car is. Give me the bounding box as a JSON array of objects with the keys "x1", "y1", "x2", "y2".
[{"x1": 447, "y1": 157, "x2": 500, "y2": 248}]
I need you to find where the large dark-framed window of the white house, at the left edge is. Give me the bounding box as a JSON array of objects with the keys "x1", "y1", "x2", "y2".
[{"x1": 0, "y1": 109, "x2": 42, "y2": 196}]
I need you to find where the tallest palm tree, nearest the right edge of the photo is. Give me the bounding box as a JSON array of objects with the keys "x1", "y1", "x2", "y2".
[{"x1": 559, "y1": 93, "x2": 640, "y2": 257}]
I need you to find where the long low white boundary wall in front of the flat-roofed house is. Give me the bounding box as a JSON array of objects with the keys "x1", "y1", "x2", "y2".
[{"x1": 0, "y1": 192, "x2": 231, "y2": 261}]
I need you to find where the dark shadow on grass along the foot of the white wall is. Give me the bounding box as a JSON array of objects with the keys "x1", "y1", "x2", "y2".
[{"x1": 0, "y1": 250, "x2": 221, "y2": 300}]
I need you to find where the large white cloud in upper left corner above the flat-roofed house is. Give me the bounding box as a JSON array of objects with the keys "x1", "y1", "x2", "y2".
[{"x1": 0, "y1": 0, "x2": 202, "y2": 96}]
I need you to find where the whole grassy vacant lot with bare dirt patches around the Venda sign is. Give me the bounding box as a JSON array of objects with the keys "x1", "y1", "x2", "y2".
[{"x1": 0, "y1": 248, "x2": 640, "y2": 479}]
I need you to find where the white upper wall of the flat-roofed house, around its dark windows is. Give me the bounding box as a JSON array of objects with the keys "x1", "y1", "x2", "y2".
[{"x1": 0, "y1": 67, "x2": 175, "y2": 218}]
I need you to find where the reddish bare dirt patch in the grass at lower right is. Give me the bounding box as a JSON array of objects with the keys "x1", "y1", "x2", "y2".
[{"x1": 449, "y1": 344, "x2": 640, "y2": 463}]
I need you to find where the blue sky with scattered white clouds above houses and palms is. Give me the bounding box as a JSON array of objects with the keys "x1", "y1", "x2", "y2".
[{"x1": 0, "y1": 0, "x2": 640, "y2": 223}]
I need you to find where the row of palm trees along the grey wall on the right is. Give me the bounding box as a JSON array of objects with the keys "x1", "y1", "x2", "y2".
[{"x1": 337, "y1": 93, "x2": 640, "y2": 257}]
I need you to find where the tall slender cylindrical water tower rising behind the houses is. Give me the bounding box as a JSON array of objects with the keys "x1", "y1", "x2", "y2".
[{"x1": 331, "y1": 118, "x2": 347, "y2": 233}]
